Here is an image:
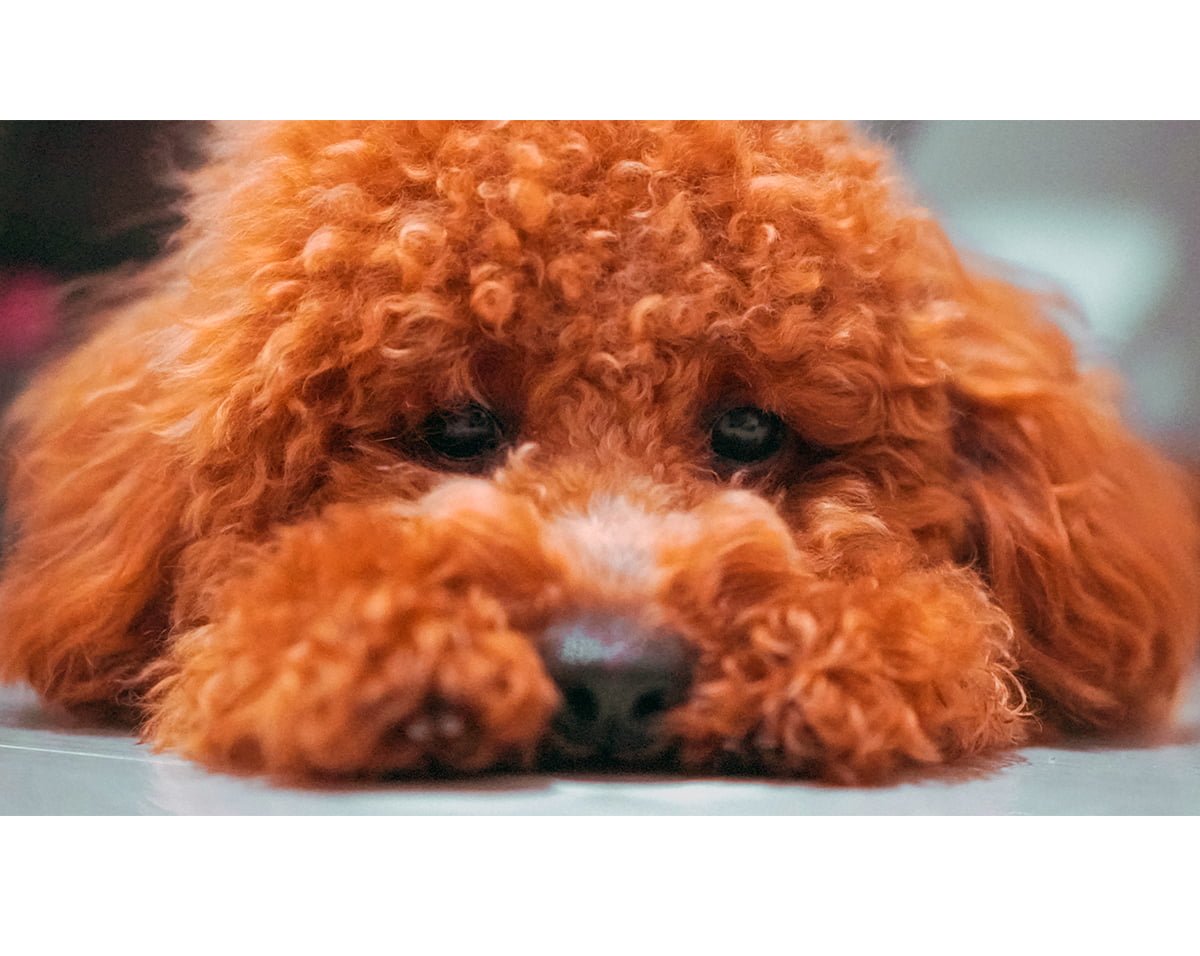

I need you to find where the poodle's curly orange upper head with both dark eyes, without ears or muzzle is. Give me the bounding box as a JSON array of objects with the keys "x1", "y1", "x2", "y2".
[{"x1": 184, "y1": 124, "x2": 965, "y2": 554}]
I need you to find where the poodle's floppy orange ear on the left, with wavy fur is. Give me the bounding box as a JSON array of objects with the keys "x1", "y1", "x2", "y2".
[{"x1": 0, "y1": 291, "x2": 186, "y2": 707}]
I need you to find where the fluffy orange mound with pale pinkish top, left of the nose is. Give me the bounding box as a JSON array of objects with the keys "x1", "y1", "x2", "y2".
[{"x1": 146, "y1": 481, "x2": 558, "y2": 777}]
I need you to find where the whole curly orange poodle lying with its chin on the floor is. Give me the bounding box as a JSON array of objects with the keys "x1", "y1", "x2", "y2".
[{"x1": 0, "y1": 122, "x2": 1200, "y2": 784}]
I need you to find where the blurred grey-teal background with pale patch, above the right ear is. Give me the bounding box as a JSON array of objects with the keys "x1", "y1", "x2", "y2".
[{"x1": 866, "y1": 121, "x2": 1200, "y2": 463}]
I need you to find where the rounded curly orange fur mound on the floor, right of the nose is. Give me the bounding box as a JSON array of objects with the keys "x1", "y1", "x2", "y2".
[{"x1": 676, "y1": 569, "x2": 1027, "y2": 784}]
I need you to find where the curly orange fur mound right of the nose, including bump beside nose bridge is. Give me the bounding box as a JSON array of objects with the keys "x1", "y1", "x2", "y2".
[{"x1": 660, "y1": 494, "x2": 1025, "y2": 783}]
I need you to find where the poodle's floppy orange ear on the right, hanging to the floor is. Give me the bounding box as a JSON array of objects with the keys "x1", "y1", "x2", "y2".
[{"x1": 928, "y1": 273, "x2": 1200, "y2": 730}]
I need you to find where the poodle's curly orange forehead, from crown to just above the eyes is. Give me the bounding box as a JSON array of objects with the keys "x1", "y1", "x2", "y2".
[{"x1": 182, "y1": 122, "x2": 929, "y2": 436}]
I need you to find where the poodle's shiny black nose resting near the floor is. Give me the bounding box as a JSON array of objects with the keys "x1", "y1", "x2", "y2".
[{"x1": 542, "y1": 614, "x2": 691, "y2": 763}]
